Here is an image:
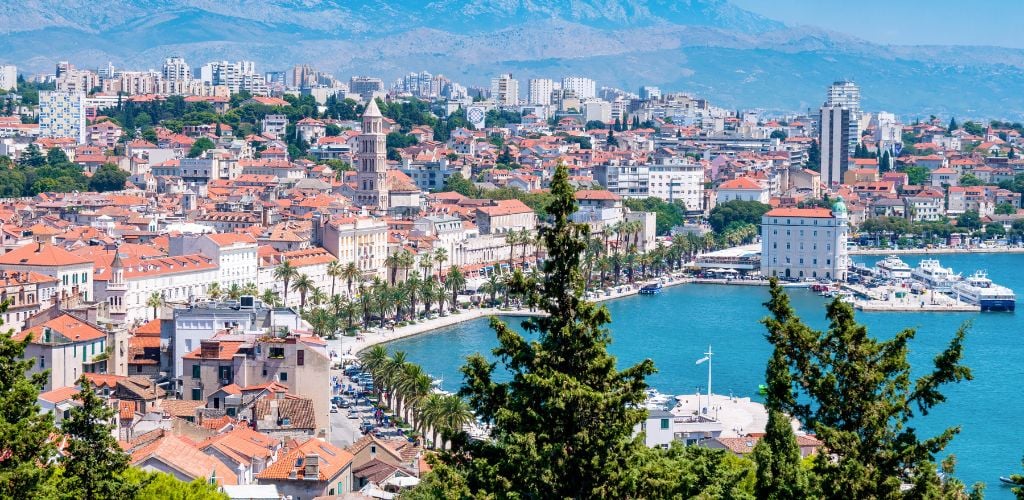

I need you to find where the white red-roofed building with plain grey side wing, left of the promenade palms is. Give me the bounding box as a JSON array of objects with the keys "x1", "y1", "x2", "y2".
[{"x1": 168, "y1": 233, "x2": 259, "y2": 290}]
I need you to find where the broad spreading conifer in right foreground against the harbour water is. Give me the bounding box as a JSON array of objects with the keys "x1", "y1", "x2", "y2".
[{"x1": 769, "y1": 280, "x2": 972, "y2": 499}]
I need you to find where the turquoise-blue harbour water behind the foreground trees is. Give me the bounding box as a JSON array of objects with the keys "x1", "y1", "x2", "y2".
[{"x1": 389, "y1": 254, "x2": 1024, "y2": 499}]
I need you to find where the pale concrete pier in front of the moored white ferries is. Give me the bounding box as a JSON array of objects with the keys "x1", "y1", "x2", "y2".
[{"x1": 843, "y1": 284, "x2": 981, "y2": 313}]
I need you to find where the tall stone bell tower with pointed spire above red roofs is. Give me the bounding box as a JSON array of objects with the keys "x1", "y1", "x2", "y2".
[{"x1": 354, "y1": 98, "x2": 388, "y2": 211}]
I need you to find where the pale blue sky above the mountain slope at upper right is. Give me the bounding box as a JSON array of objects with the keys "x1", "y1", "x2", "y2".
[{"x1": 732, "y1": 0, "x2": 1024, "y2": 48}]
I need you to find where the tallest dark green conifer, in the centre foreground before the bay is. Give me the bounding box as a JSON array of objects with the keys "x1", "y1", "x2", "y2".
[{"x1": 444, "y1": 165, "x2": 654, "y2": 498}]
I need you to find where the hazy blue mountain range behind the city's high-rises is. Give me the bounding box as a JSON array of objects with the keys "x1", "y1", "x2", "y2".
[{"x1": 6, "y1": 0, "x2": 1024, "y2": 120}]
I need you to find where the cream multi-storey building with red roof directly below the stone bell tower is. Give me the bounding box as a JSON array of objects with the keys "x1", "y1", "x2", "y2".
[{"x1": 323, "y1": 217, "x2": 387, "y2": 279}]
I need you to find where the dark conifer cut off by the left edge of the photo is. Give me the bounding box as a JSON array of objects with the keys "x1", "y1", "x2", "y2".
[{"x1": 0, "y1": 302, "x2": 56, "y2": 498}]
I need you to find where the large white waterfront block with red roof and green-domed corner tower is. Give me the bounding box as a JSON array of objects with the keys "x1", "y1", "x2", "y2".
[{"x1": 761, "y1": 198, "x2": 850, "y2": 280}]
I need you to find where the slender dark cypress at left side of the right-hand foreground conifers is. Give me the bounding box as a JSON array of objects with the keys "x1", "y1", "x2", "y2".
[{"x1": 754, "y1": 279, "x2": 812, "y2": 500}]
